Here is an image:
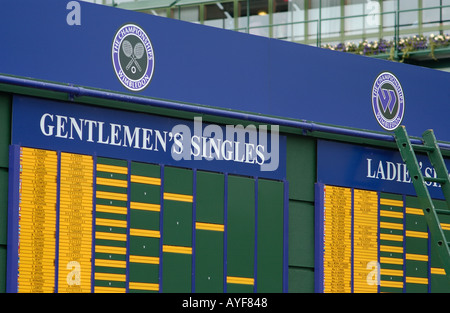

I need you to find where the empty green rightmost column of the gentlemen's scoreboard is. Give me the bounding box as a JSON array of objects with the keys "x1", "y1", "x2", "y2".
[{"x1": 256, "y1": 179, "x2": 284, "y2": 292}]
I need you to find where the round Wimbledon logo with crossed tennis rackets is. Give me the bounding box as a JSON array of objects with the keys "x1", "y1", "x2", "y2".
[{"x1": 112, "y1": 24, "x2": 155, "y2": 91}]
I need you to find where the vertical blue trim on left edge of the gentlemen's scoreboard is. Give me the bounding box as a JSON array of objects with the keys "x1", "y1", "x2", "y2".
[{"x1": 6, "y1": 145, "x2": 20, "y2": 293}]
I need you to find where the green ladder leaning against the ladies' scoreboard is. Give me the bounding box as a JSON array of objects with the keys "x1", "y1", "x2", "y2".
[{"x1": 394, "y1": 126, "x2": 450, "y2": 282}]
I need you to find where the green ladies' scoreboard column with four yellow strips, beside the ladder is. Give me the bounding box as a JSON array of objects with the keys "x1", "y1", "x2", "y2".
[{"x1": 405, "y1": 197, "x2": 429, "y2": 293}]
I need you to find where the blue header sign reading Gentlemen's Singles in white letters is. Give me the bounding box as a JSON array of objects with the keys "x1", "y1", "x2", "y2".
[{"x1": 12, "y1": 96, "x2": 286, "y2": 179}]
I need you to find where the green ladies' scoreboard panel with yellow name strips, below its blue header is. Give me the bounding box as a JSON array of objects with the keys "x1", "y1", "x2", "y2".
[{"x1": 316, "y1": 184, "x2": 450, "y2": 293}]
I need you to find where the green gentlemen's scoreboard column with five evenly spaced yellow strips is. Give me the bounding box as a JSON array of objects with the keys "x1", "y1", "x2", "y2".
[{"x1": 129, "y1": 162, "x2": 161, "y2": 292}]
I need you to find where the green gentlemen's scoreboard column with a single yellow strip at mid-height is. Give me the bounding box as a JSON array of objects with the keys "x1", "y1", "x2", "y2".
[{"x1": 195, "y1": 171, "x2": 225, "y2": 292}]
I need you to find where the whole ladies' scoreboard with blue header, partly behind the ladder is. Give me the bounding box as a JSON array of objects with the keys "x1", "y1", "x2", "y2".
[{"x1": 315, "y1": 141, "x2": 450, "y2": 293}]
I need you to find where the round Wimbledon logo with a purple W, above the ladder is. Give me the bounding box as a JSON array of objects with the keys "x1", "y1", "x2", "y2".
[{"x1": 372, "y1": 72, "x2": 405, "y2": 131}]
